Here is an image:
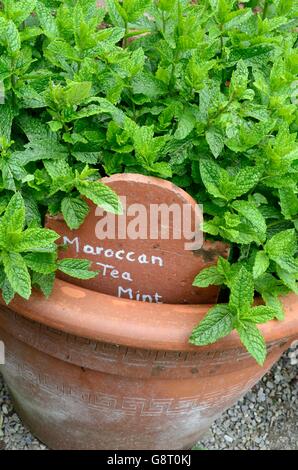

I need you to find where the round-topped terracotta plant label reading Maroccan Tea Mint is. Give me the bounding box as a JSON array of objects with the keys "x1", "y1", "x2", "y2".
[{"x1": 47, "y1": 174, "x2": 228, "y2": 304}]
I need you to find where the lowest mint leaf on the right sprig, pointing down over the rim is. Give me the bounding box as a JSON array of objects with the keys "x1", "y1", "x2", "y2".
[{"x1": 237, "y1": 321, "x2": 267, "y2": 366}]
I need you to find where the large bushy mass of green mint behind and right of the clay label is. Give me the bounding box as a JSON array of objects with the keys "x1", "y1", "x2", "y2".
[{"x1": 0, "y1": 0, "x2": 298, "y2": 364}]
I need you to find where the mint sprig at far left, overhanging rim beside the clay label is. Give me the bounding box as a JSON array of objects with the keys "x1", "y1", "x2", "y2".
[{"x1": 0, "y1": 192, "x2": 97, "y2": 303}]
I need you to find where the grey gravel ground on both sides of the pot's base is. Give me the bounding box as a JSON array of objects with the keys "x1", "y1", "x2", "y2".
[{"x1": 0, "y1": 344, "x2": 298, "y2": 450}]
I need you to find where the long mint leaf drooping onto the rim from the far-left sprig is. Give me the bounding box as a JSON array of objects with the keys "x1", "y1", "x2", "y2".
[{"x1": 2, "y1": 252, "x2": 31, "y2": 299}]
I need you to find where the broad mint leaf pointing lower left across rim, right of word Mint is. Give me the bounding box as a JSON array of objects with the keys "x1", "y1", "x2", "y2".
[{"x1": 190, "y1": 304, "x2": 233, "y2": 346}]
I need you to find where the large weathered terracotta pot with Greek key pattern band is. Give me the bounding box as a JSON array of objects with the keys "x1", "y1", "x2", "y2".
[{"x1": 0, "y1": 280, "x2": 298, "y2": 450}]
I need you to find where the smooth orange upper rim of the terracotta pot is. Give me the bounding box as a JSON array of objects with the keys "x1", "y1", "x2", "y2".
[{"x1": 0, "y1": 279, "x2": 298, "y2": 352}]
